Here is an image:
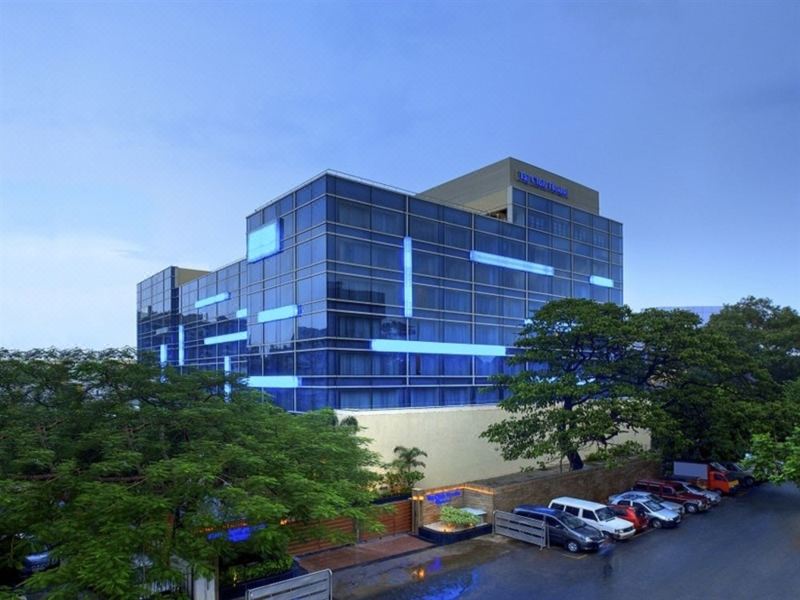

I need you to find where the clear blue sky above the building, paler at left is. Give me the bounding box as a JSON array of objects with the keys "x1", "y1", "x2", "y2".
[{"x1": 0, "y1": 1, "x2": 800, "y2": 348}]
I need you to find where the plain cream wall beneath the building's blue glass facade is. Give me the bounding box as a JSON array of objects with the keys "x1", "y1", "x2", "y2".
[{"x1": 336, "y1": 406, "x2": 650, "y2": 488}]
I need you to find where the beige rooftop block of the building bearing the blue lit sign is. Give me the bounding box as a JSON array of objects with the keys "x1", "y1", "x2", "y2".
[{"x1": 419, "y1": 157, "x2": 600, "y2": 217}]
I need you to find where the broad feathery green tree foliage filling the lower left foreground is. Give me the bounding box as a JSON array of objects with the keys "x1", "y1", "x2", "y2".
[{"x1": 0, "y1": 350, "x2": 377, "y2": 598}]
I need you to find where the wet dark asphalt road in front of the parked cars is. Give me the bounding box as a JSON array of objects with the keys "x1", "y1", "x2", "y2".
[{"x1": 334, "y1": 485, "x2": 800, "y2": 600}]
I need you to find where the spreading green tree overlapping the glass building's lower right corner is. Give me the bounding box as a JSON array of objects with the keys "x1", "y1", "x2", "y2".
[{"x1": 481, "y1": 299, "x2": 688, "y2": 470}]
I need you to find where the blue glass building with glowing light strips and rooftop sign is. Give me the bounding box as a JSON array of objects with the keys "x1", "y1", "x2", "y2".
[{"x1": 137, "y1": 158, "x2": 623, "y2": 411}]
